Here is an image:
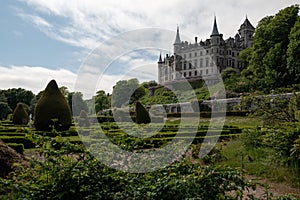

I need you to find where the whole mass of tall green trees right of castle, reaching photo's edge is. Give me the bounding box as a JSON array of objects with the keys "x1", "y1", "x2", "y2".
[{"x1": 239, "y1": 5, "x2": 299, "y2": 93}]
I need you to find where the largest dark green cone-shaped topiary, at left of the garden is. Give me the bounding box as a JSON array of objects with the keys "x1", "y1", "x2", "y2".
[{"x1": 34, "y1": 80, "x2": 72, "y2": 131}]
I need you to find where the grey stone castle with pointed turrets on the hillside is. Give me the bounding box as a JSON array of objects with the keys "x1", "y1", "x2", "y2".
[{"x1": 158, "y1": 17, "x2": 255, "y2": 85}]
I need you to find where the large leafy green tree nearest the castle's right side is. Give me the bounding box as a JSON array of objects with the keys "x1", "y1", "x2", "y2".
[{"x1": 242, "y1": 5, "x2": 299, "y2": 92}]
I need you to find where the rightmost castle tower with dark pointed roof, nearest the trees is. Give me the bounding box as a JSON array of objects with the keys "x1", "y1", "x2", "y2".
[{"x1": 238, "y1": 16, "x2": 255, "y2": 48}]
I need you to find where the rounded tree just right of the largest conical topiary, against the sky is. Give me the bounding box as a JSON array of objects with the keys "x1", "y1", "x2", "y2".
[{"x1": 67, "y1": 92, "x2": 88, "y2": 116}]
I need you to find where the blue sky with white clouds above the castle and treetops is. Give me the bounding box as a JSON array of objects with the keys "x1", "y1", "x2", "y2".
[{"x1": 0, "y1": 0, "x2": 300, "y2": 98}]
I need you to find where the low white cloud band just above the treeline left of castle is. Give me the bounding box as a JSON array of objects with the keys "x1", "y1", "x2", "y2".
[{"x1": 0, "y1": 65, "x2": 156, "y2": 98}]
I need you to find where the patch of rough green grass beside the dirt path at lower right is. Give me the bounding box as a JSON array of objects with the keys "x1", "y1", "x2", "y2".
[{"x1": 222, "y1": 139, "x2": 300, "y2": 188}]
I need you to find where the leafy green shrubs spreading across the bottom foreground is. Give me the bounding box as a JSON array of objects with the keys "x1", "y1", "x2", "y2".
[{"x1": 0, "y1": 138, "x2": 255, "y2": 200}]
